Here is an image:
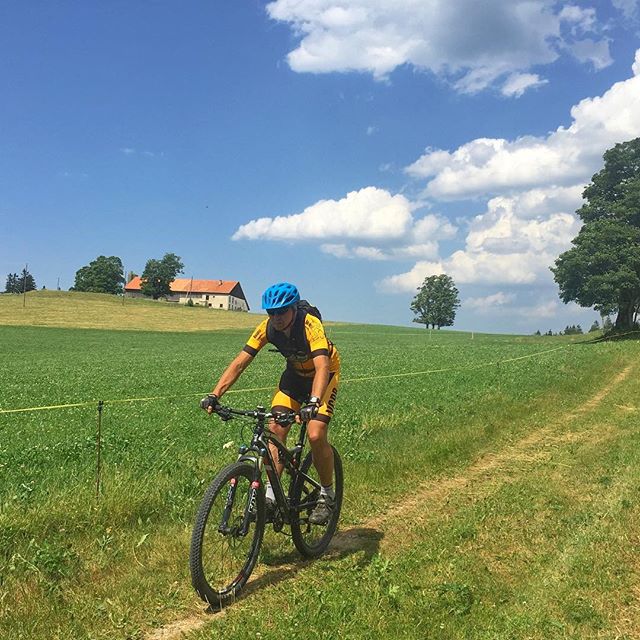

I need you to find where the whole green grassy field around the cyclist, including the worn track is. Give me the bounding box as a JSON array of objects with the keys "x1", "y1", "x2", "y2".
[{"x1": 0, "y1": 294, "x2": 640, "y2": 639}]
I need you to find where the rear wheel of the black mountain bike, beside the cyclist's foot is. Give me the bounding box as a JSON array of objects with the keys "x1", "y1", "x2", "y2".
[{"x1": 289, "y1": 447, "x2": 344, "y2": 558}]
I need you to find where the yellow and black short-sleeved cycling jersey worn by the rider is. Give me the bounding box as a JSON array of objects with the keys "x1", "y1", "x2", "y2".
[{"x1": 243, "y1": 311, "x2": 340, "y2": 378}]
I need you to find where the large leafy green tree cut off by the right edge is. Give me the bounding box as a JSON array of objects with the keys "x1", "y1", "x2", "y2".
[{"x1": 551, "y1": 138, "x2": 640, "y2": 331}]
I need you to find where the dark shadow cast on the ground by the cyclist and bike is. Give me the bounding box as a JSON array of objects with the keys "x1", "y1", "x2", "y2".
[{"x1": 206, "y1": 527, "x2": 384, "y2": 614}]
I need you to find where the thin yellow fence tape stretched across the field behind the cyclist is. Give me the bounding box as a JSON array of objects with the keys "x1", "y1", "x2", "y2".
[{"x1": 0, "y1": 331, "x2": 640, "y2": 415}]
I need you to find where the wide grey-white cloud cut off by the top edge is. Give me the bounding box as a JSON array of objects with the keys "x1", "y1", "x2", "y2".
[{"x1": 267, "y1": 0, "x2": 610, "y2": 96}]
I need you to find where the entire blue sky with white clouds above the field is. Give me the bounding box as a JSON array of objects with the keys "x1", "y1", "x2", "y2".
[{"x1": 0, "y1": 0, "x2": 640, "y2": 333}]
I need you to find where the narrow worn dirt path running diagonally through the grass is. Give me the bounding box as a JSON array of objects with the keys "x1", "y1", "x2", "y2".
[{"x1": 147, "y1": 365, "x2": 633, "y2": 640}]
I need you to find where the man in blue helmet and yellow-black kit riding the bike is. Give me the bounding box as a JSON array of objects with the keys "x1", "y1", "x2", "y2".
[{"x1": 201, "y1": 282, "x2": 340, "y2": 524}]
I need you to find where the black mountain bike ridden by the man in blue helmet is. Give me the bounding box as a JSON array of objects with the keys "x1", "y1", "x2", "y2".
[{"x1": 189, "y1": 406, "x2": 343, "y2": 608}]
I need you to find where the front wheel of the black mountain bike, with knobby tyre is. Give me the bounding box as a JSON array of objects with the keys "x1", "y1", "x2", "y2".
[{"x1": 189, "y1": 462, "x2": 265, "y2": 608}]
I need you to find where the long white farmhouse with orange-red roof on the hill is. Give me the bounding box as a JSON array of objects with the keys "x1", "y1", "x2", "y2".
[{"x1": 124, "y1": 276, "x2": 249, "y2": 311}]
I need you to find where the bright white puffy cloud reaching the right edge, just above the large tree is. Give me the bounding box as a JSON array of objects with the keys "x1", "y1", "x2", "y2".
[{"x1": 406, "y1": 53, "x2": 640, "y2": 199}]
